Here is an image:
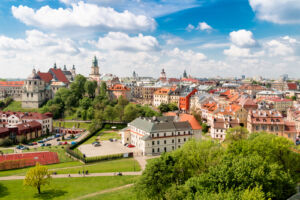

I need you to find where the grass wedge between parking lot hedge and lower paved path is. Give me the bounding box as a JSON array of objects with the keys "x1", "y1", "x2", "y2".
[{"x1": 51, "y1": 158, "x2": 141, "y2": 174}]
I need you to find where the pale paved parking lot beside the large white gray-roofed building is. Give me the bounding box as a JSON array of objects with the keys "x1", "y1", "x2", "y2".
[{"x1": 78, "y1": 141, "x2": 138, "y2": 157}]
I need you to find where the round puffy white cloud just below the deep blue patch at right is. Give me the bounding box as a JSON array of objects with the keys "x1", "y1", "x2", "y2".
[{"x1": 229, "y1": 29, "x2": 256, "y2": 47}]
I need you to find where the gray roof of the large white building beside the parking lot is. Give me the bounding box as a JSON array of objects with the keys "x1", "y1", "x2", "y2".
[{"x1": 129, "y1": 116, "x2": 192, "y2": 133}]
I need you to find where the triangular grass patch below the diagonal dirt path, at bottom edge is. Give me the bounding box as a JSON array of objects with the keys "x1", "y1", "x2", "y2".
[{"x1": 84, "y1": 187, "x2": 137, "y2": 200}]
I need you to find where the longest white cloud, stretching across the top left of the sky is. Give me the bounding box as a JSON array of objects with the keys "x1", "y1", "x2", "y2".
[{"x1": 12, "y1": 1, "x2": 156, "y2": 31}]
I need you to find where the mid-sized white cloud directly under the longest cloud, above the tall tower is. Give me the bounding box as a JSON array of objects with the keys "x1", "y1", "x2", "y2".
[{"x1": 96, "y1": 32, "x2": 159, "y2": 51}]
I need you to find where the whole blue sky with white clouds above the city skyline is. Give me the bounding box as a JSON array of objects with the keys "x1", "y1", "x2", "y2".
[{"x1": 0, "y1": 0, "x2": 300, "y2": 78}]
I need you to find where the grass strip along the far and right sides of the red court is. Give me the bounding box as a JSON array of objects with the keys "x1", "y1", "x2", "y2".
[{"x1": 23, "y1": 146, "x2": 73, "y2": 163}]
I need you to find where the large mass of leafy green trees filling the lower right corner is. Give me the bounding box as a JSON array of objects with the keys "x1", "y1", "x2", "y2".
[{"x1": 135, "y1": 133, "x2": 300, "y2": 200}]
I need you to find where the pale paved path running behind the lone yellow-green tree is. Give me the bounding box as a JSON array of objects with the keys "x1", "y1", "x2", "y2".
[{"x1": 0, "y1": 171, "x2": 142, "y2": 181}]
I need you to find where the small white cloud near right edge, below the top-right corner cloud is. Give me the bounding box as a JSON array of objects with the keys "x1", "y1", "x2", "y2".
[{"x1": 266, "y1": 40, "x2": 294, "y2": 57}]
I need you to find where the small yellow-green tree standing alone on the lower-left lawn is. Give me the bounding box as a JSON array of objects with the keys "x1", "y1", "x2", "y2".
[{"x1": 24, "y1": 163, "x2": 51, "y2": 194}]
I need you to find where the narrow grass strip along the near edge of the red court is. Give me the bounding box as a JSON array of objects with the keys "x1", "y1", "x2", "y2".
[{"x1": 0, "y1": 161, "x2": 83, "y2": 177}]
